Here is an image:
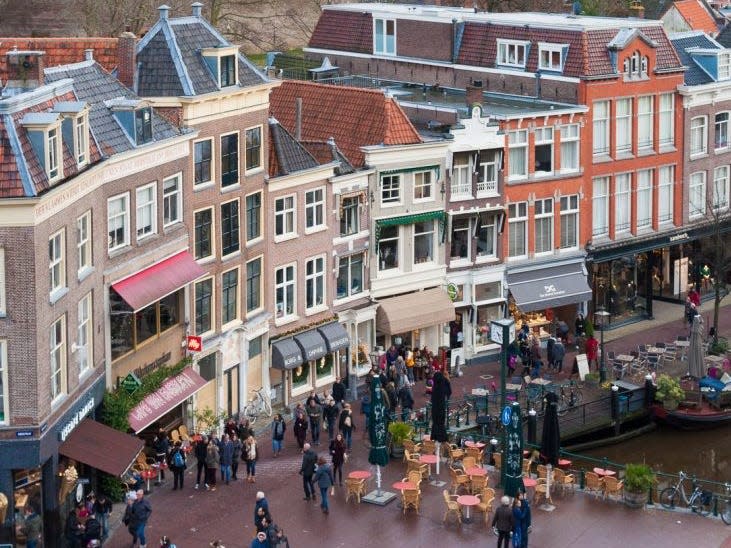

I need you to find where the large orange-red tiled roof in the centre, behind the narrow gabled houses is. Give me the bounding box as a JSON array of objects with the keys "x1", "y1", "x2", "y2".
[{"x1": 269, "y1": 80, "x2": 421, "y2": 168}]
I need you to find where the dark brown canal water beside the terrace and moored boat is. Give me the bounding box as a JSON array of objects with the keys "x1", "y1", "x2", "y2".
[{"x1": 581, "y1": 425, "x2": 731, "y2": 482}]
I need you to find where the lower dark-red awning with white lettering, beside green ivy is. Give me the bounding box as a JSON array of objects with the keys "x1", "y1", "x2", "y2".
[{"x1": 127, "y1": 367, "x2": 208, "y2": 433}]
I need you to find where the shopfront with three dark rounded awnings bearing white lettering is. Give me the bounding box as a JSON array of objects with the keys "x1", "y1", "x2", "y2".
[{"x1": 271, "y1": 322, "x2": 350, "y2": 403}]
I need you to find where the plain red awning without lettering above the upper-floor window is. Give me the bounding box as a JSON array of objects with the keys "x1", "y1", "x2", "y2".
[{"x1": 112, "y1": 251, "x2": 206, "y2": 311}]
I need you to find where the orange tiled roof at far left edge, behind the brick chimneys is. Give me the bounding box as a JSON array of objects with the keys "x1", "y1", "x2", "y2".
[{"x1": 0, "y1": 38, "x2": 117, "y2": 82}]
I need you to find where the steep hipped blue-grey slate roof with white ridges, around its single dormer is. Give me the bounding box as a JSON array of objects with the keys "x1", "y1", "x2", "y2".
[{"x1": 137, "y1": 11, "x2": 268, "y2": 97}]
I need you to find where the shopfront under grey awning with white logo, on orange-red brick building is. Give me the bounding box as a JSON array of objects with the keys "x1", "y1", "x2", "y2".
[{"x1": 506, "y1": 257, "x2": 592, "y2": 338}]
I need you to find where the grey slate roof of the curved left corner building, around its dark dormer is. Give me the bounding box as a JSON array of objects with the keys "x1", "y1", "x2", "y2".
[{"x1": 45, "y1": 61, "x2": 180, "y2": 156}]
